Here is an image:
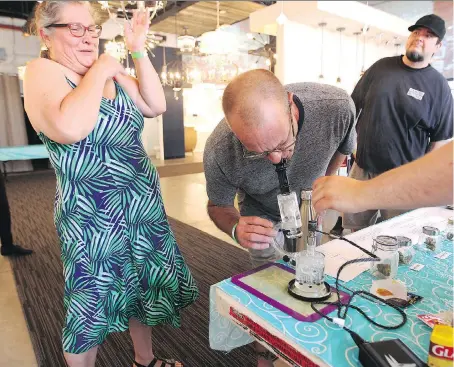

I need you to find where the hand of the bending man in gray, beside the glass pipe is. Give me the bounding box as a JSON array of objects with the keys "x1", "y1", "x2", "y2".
[{"x1": 235, "y1": 217, "x2": 277, "y2": 250}]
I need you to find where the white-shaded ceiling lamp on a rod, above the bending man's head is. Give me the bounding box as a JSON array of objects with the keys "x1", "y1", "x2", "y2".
[{"x1": 200, "y1": 1, "x2": 238, "y2": 55}]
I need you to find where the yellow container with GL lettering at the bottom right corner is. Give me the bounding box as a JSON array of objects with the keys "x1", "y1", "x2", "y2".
[{"x1": 427, "y1": 325, "x2": 454, "y2": 367}]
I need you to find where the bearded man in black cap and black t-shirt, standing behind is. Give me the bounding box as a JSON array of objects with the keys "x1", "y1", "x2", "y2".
[{"x1": 344, "y1": 14, "x2": 453, "y2": 230}]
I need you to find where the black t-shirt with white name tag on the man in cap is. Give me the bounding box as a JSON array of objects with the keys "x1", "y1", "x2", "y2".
[{"x1": 352, "y1": 56, "x2": 453, "y2": 174}]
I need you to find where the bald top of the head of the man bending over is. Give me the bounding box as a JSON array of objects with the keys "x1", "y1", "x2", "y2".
[{"x1": 222, "y1": 69, "x2": 288, "y2": 127}]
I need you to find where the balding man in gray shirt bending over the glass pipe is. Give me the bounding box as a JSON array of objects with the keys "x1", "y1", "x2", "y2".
[{"x1": 204, "y1": 70, "x2": 356, "y2": 266}]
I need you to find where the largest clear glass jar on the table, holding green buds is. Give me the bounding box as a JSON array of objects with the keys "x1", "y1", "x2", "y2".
[{"x1": 371, "y1": 236, "x2": 399, "y2": 279}]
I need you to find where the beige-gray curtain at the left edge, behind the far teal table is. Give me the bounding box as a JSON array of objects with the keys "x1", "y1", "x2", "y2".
[{"x1": 0, "y1": 74, "x2": 33, "y2": 172}]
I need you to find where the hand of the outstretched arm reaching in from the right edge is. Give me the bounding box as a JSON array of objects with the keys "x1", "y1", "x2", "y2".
[{"x1": 312, "y1": 176, "x2": 368, "y2": 213}]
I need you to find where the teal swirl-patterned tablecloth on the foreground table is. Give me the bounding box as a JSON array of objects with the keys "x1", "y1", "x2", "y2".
[{"x1": 210, "y1": 212, "x2": 453, "y2": 367}]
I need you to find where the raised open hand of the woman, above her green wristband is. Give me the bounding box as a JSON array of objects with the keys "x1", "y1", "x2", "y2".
[{"x1": 125, "y1": 9, "x2": 150, "y2": 52}]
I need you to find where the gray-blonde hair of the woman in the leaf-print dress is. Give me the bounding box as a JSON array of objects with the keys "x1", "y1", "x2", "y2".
[{"x1": 30, "y1": 1, "x2": 98, "y2": 59}]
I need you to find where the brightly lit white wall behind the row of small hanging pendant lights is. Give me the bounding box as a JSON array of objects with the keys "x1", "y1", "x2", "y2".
[{"x1": 276, "y1": 21, "x2": 402, "y2": 93}]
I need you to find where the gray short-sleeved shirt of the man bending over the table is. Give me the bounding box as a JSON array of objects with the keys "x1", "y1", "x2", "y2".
[{"x1": 203, "y1": 83, "x2": 356, "y2": 221}]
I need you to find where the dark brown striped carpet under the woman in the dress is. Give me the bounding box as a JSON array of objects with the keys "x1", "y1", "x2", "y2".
[{"x1": 7, "y1": 171, "x2": 254, "y2": 367}]
